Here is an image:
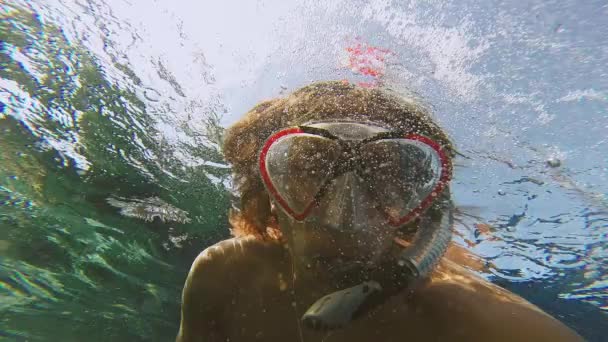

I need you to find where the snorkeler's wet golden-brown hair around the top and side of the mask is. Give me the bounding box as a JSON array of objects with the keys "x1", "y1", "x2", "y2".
[{"x1": 223, "y1": 81, "x2": 454, "y2": 239}]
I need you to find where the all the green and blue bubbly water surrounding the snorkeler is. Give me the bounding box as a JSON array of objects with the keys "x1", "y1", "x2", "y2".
[{"x1": 0, "y1": 0, "x2": 608, "y2": 341}]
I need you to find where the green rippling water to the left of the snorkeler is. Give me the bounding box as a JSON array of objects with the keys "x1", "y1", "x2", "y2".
[{"x1": 0, "y1": 3, "x2": 230, "y2": 341}]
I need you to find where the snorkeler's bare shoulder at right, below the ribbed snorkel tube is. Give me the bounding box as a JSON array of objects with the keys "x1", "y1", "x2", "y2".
[{"x1": 413, "y1": 258, "x2": 583, "y2": 341}]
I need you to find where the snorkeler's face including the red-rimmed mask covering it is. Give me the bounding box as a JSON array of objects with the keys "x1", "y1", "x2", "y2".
[{"x1": 260, "y1": 122, "x2": 450, "y2": 284}]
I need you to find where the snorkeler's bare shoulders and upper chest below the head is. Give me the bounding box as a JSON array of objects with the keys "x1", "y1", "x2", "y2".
[{"x1": 177, "y1": 237, "x2": 582, "y2": 342}]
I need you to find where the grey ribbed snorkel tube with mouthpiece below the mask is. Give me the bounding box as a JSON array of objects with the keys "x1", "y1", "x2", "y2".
[{"x1": 302, "y1": 203, "x2": 454, "y2": 330}]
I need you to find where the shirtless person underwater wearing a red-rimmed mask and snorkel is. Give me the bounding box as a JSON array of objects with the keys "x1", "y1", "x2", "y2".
[{"x1": 177, "y1": 82, "x2": 582, "y2": 342}]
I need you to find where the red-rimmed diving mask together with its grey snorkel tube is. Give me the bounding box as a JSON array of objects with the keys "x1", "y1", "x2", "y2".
[{"x1": 259, "y1": 121, "x2": 453, "y2": 329}]
